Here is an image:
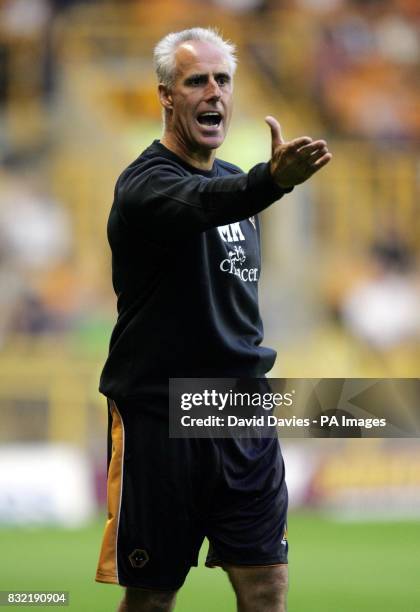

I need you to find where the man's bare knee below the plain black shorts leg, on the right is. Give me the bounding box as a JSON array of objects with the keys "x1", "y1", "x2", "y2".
[{"x1": 226, "y1": 565, "x2": 288, "y2": 612}]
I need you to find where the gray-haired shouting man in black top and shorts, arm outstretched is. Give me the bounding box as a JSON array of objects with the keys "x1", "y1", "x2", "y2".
[{"x1": 97, "y1": 28, "x2": 331, "y2": 612}]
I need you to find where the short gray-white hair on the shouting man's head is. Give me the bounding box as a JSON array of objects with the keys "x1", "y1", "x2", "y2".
[{"x1": 153, "y1": 28, "x2": 237, "y2": 87}]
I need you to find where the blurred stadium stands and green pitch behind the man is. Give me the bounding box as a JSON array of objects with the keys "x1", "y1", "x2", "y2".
[{"x1": 0, "y1": 0, "x2": 420, "y2": 612}]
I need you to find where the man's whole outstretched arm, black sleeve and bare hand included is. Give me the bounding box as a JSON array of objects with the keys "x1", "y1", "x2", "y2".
[{"x1": 117, "y1": 117, "x2": 332, "y2": 236}]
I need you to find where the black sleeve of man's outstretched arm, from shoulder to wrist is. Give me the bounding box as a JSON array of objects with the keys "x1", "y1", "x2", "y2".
[{"x1": 117, "y1": 160, "x2": 290, "y2": 235}]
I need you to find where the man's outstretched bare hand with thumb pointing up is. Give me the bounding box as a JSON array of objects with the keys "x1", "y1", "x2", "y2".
[{"x1": 265, "y1": 116, "x2": 332, "y2": 189}]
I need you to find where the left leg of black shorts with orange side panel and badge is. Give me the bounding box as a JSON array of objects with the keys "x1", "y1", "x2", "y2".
[{"x1": 96, "y1": 401, "x2": 204, "y2": 591}]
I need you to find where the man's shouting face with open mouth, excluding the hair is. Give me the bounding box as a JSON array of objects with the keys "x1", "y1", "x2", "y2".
[{"x1": 161, "y1": 41, "x2": 233, "y2": 153}]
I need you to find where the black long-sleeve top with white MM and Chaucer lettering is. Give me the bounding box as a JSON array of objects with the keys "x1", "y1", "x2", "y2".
[{"x1": 100, "y1": 141, "x2": 285, "y2": 400}]
